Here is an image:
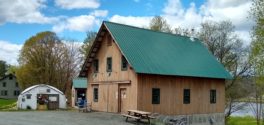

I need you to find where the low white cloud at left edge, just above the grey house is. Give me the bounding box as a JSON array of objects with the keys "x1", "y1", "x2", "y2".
[{"x1": 0, "y1": 40, "x2": 22, "y2": 65}]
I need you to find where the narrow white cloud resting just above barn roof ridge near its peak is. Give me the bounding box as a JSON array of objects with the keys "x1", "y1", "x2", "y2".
[{"x1": 110, "y1": 15, "x2": 153, "y2": 27}]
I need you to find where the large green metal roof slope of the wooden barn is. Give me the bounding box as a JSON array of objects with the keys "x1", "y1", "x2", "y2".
[{"x1": 103, "y1": 22, "x2": 232, "y2": 79}]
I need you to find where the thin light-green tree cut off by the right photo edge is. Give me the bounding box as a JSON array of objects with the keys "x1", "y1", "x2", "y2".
[{"x1": 250, "y1": 0, "x2": 264, "y2": 125}]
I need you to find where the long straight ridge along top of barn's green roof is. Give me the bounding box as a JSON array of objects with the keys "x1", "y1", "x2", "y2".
[{"x1": 103, "y1": 21, "x2": 199, "y2": 40}]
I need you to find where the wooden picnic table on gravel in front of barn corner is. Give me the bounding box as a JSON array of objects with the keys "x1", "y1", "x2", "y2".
[{"x1": 123, "y1": 110, "x2": 154, "y2": 124}]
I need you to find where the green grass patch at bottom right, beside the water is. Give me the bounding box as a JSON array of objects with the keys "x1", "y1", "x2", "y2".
[{"x1": 228, "y1": 116, "x2": 257, "y2": 125}]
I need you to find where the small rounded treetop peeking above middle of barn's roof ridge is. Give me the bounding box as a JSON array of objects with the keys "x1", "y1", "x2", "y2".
[{"x1": 149, "y1": 16, "x2": 172, "y2": 33}]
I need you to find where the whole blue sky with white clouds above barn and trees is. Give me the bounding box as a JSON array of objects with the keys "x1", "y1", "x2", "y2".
[{"x1": 0, "y1": 0, "x2": 254, "y2": 65}]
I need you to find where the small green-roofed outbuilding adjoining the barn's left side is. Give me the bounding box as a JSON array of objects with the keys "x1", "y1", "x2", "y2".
[{"x1": 72, "y1": 78, "x2": 87, "y2": 107}]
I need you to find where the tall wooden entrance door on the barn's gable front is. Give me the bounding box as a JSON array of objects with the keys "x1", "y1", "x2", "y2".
[{"x1": 118, "y1": 88, "x2": 127, "y2": 113}]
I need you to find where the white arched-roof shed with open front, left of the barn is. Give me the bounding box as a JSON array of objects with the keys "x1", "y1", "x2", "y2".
[{"x1": 17, "y1": 84, "x2": 66, "y2": 110}]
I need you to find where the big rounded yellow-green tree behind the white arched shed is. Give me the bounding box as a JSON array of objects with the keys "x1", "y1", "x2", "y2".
[{"x1": 16, "y1": 31, "x2": 80, "y2": 93}]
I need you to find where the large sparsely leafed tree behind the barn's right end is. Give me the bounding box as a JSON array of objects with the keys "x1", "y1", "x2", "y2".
[{"x1": 198, "y1": 21, "x2": 251, "y2": 121}]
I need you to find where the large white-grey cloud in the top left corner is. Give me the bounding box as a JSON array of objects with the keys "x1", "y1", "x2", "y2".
[{"x1": 0, "y1": 0, "x2": 58, "y2": 24}]
